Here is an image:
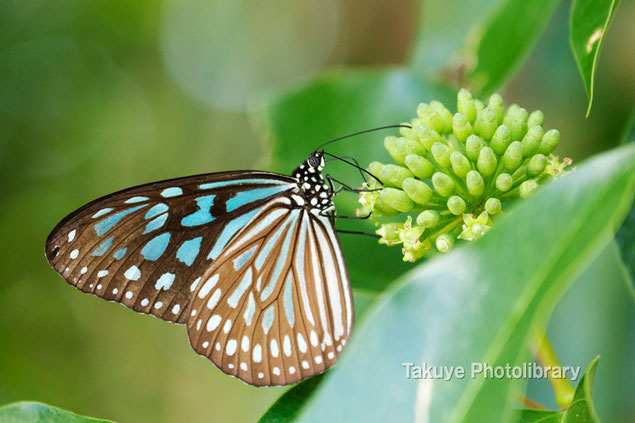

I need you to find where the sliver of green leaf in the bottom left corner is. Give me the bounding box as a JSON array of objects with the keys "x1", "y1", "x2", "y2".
[{"x1": 0, "y1": 401, "x2": 110, "y2": 423}]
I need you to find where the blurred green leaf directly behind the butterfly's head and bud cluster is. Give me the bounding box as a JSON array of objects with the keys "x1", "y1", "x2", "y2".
[{"x1": 255, "y1": 68, "x2": 456, "y2": 291}]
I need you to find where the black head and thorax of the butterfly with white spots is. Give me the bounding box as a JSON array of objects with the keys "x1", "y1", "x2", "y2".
[{"x1": 292, "y1": 152, "x2": 335, "y2": 214}]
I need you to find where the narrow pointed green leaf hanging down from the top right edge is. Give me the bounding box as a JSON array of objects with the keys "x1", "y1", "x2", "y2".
[{"x1": 570, "y1": 0, "x2": 620, "y2": 116}]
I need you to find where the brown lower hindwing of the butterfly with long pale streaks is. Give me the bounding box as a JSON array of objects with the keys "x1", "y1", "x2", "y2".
[{"x1": 188, "y1": 196, "x2": 353, "y2": 386}]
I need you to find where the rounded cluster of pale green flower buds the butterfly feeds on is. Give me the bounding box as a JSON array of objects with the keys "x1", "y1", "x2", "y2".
[{"x1": 357, "y1": 90, "x2": 571, "y2": 261}]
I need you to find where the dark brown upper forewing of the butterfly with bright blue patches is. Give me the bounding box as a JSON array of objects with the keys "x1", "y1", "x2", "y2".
[{"x1": 45, "y1": 171, "x2": 296, "y2": 323}]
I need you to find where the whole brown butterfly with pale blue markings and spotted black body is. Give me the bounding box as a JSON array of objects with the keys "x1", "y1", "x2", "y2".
[{"x1": 45, "y1": 150, "x2": 354, "y2": 386}]
